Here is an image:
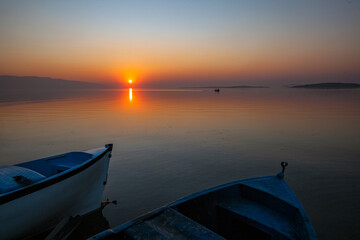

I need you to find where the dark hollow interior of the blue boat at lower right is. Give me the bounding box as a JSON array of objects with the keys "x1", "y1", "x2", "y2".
[{"x1": 175, "y1": 184, "x2": 305, "y2": 239}]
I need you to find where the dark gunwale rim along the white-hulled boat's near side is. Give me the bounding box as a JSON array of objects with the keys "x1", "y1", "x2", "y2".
[{"x1": 0, "y1": 144, "x2": 113, "y2": 205}]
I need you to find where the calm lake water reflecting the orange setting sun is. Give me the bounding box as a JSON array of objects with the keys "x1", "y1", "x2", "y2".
[{"x1": 0, "y1": 88, "x2": 360, "y2": 239}]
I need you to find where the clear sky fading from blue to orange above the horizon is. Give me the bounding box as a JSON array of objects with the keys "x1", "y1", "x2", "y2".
[{"x1": 0, "y1": 0, "x2": 360, "y2": 87}]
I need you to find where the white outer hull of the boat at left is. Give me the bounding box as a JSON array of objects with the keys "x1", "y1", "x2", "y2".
[{"x1": 0, "y1": 145, "x2": 112, "y2": 239}]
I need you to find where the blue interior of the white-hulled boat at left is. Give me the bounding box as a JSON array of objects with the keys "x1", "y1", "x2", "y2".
[{"x1": 0, "y1": 152, "x2": 93, "y2": 195}]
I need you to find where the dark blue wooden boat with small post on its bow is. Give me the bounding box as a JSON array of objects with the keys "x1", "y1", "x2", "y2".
[{"x1": 91, "y1": 163, "x2": 317, "y2": 240}]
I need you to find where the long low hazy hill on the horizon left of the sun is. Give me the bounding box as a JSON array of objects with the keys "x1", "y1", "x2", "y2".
[{"x1": 0, "y1": 75, "x2": 105, "y2": 90}]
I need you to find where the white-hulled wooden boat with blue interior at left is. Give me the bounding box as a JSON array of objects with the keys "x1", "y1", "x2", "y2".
[{"x1": 0, "y1": 144, "x2": 113, "y2": 239}]
